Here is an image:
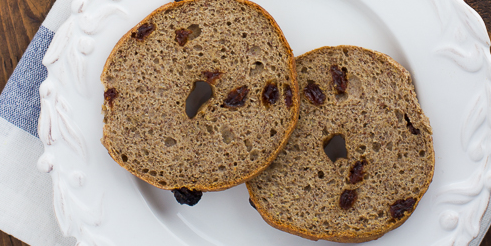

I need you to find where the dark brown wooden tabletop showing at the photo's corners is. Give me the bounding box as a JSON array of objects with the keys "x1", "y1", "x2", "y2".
[{"x1": 0, "y1": 0, "x2": 491, "y2": 246}]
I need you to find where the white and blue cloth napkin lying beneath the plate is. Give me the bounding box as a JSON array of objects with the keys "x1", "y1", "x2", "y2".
[{"x1": 0, "y1": 0, "x2": 491, "y2": 246}]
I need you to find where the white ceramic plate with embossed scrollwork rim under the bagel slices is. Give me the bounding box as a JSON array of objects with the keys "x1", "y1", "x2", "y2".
[{"x1": 38, "y1": 0, "x2": 491, "y2": 246}]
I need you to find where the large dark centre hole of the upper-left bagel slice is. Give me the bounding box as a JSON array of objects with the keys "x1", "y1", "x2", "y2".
[{"x1": 186, "y1": 81, "x2": 213, "y2": 119}]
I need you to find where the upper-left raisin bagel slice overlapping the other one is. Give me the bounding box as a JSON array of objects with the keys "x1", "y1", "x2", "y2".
[{"x1": 101, "y1": 0, "x2": 299, "y2": 191}]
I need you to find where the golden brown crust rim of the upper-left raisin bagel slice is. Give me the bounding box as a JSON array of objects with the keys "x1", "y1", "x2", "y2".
[{"x1": 101, "y1": 0, "x2": 300, "y2": 191}]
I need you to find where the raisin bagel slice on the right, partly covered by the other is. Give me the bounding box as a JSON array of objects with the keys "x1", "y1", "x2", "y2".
[{"x1": 247, "y1": 46, "x2": 435, "y2": 243}]
